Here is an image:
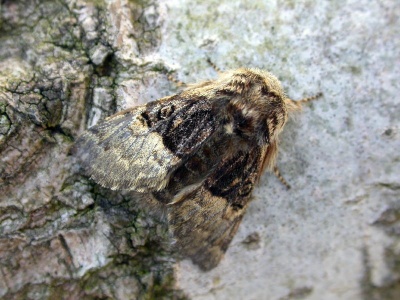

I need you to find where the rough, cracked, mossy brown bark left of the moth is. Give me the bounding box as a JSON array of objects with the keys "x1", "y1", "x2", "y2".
[{"x1": 0, "y1": 1, "x2": 182, "y2": 299}]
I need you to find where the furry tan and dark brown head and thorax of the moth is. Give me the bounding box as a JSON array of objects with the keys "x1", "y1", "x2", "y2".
[{"x1": 208, "y1": 69, "x2": 287, "y2": 146}]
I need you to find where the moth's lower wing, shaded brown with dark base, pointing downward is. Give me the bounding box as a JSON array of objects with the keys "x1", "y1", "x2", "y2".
[{"x1": 168, "y1": 147, "x2": 265, "y2": 270}]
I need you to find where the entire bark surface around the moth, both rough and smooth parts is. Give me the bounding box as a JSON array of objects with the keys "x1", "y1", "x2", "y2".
[{"x1": 0, "y1": 0, "x2": 400, "y2": 300}]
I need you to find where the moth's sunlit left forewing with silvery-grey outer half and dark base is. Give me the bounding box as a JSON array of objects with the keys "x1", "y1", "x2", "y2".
[{"x1": 75, "y1": 95, "x2": 219, "y2": 192}]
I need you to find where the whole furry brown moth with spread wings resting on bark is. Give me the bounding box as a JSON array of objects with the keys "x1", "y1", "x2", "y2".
[{"x1": 77, "y1": 69, "x2": 316, "y2": 270}]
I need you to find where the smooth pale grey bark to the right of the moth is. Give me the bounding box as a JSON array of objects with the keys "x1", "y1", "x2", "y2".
[{"x1": 159, "y1": 0, "x2": 400, "y2": 300}]
